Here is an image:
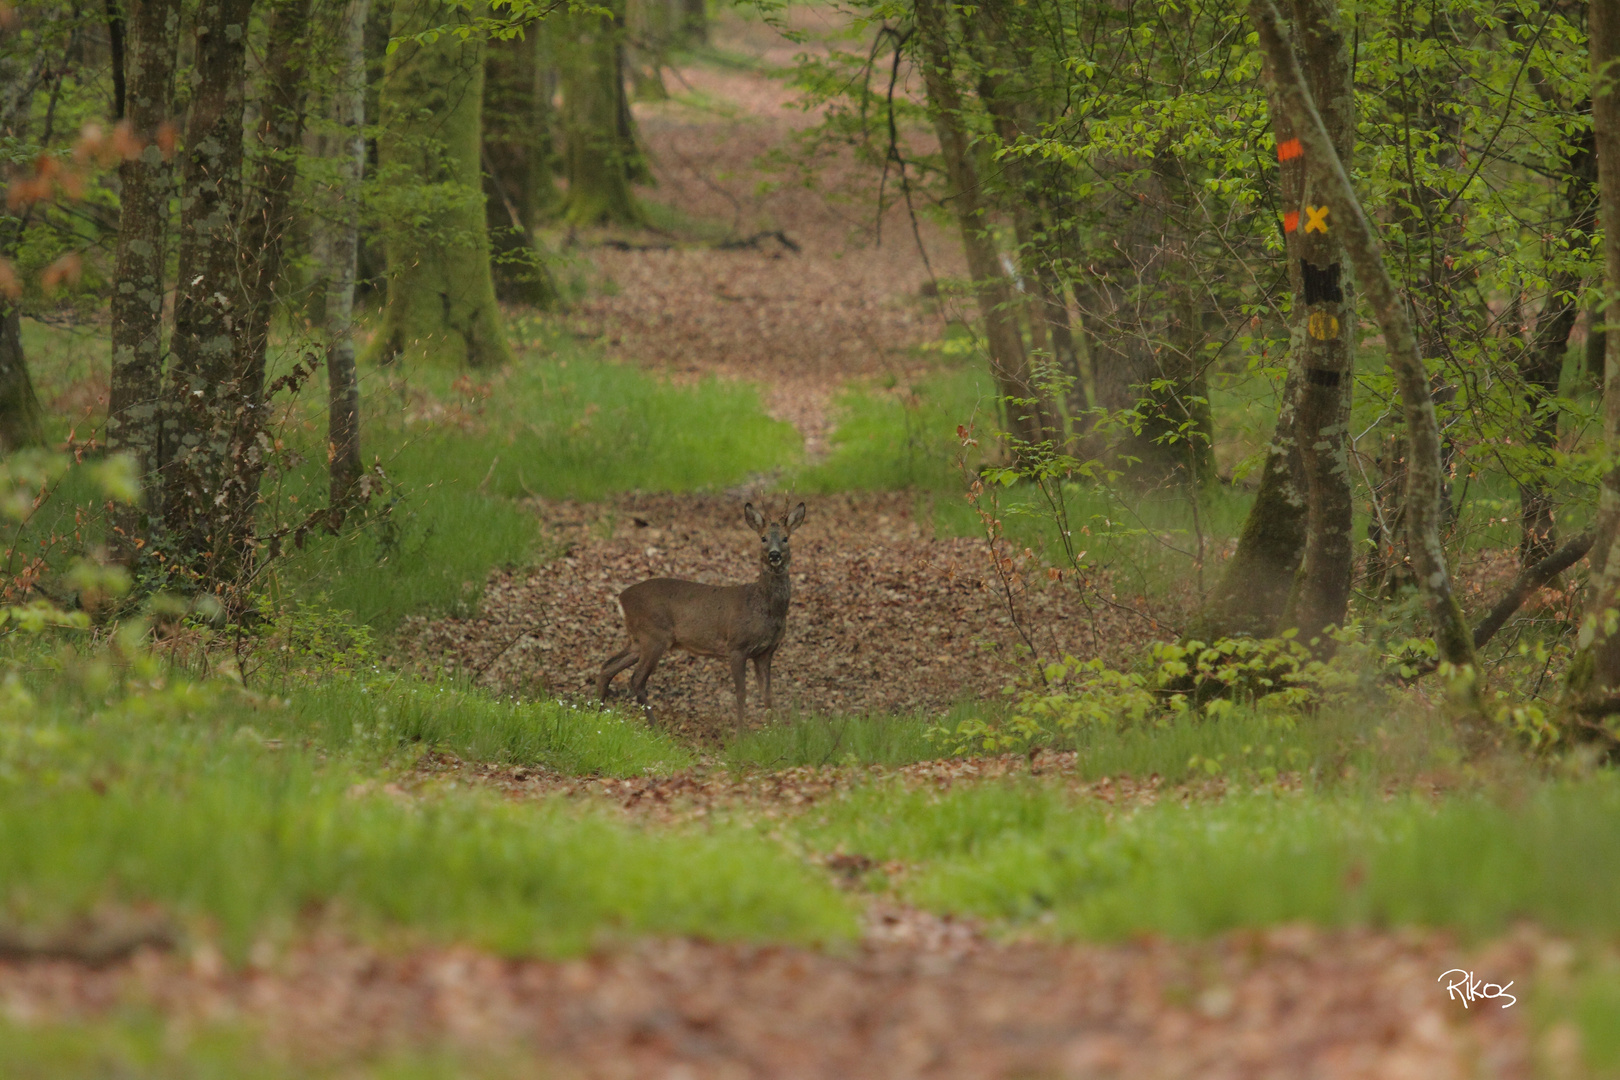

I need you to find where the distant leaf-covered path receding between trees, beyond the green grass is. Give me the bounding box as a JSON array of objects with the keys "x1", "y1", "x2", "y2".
[{"x1": 569, "y1": 6, "x2": 961, "y2": 458}]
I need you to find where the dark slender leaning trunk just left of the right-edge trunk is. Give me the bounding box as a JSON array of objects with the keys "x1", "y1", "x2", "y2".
[{"x1": 1520, "y1": 102, "x2": 1597, "y2": 567}]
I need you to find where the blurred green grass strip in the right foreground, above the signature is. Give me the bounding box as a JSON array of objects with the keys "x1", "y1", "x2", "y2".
[{"x1": 800, "y1": 777, "x2": 1620, "y2": 939}]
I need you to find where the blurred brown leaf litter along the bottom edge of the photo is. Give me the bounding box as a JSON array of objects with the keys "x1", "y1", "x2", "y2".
[{"x1": 0, "y1": 912, "x2": 1542, "y2": 1080}]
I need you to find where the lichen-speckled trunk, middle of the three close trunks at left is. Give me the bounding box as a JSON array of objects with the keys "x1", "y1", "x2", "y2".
[{"x1": 160, "y1": 0, "x2": 253, "y2": 591}]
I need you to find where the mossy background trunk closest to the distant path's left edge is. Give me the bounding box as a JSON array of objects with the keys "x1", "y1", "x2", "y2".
[{"x1": 559, "y1": 4, "x2": 646, "y2": 225}]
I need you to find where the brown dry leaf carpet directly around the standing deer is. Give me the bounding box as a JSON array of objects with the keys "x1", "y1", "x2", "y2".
[{"x1": 402, "y1": 494, "x2": 1160, "y2": 733}]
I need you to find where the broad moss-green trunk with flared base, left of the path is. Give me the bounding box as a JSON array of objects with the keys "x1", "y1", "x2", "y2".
[{"x1": 371, "y1": 0, "x2": 512, "y2": 368}]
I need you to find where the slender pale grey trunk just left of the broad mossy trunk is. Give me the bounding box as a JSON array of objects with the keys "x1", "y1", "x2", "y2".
[{"x1": 322, "y1": 0, "x2": 371, "y2": 518}]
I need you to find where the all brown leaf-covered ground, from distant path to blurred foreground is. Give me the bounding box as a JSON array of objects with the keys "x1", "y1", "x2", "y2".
[{"x1": 0, "y1": 8, "x2": 1578, "y2": 1080}]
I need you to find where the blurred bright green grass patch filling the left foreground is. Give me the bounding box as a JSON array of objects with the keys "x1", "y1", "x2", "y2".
[{"x1": 0, "y1": 680, "x2": 854, "y2": 957}]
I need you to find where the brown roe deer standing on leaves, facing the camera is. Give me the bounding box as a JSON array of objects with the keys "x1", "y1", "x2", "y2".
[{"x1": 596, "y1": 502, "x2": 805, "y2": 724}]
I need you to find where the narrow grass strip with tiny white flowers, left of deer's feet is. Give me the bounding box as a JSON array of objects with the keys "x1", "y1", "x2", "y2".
[{"x1": 273, "y1": 678, "x2": 693, "y2": 776}]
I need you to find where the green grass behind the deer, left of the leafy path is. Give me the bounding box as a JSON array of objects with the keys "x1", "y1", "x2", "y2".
[{"x1": 264, "y1": 321, "x2": 800, "y2": 630}]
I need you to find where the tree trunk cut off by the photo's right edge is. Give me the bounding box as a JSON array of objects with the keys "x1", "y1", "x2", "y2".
[{"x1": 1565, "y1": 0, "x2": 1620, "y2": 712}]
